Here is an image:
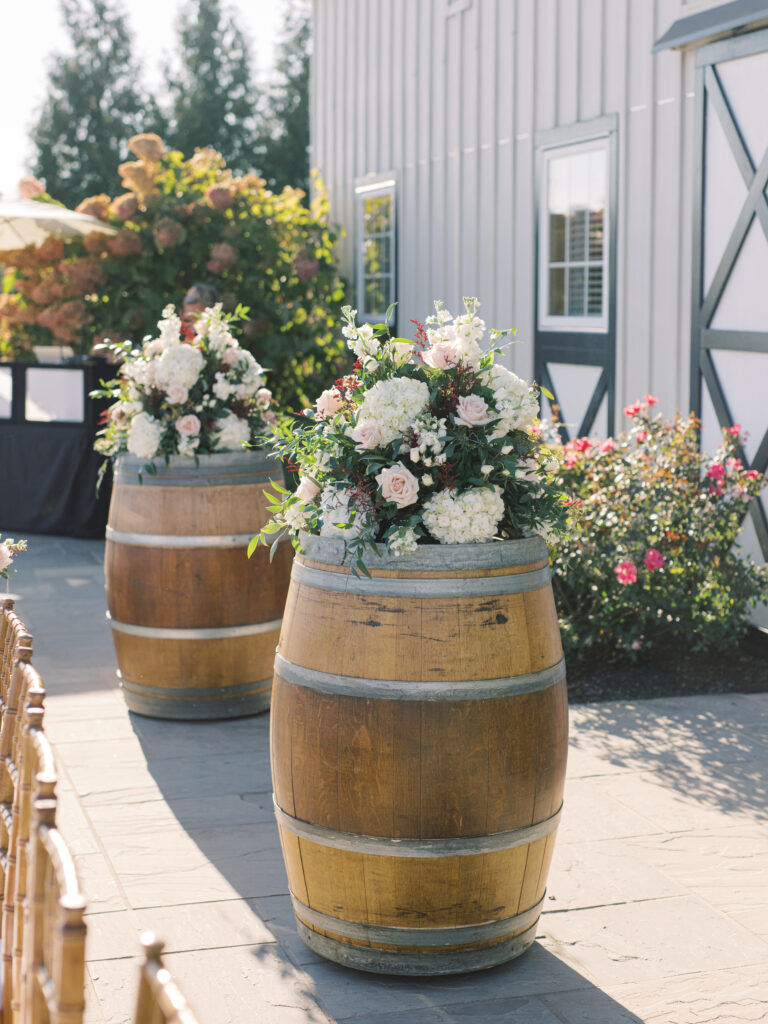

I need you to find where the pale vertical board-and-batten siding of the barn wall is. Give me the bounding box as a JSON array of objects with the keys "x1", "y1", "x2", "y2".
[{"x1": 311, "y1": 0, "x2": 693, "y2": 427}]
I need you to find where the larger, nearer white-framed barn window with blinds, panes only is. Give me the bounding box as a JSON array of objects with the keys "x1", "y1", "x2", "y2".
[{"x1": 539, "y1": 136, "x2": 610, "y2": 332}]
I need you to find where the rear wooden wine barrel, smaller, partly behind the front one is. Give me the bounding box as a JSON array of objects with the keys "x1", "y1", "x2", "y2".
[{"x1": 104, "y1": 451, "x2": 293, "y2": 719}]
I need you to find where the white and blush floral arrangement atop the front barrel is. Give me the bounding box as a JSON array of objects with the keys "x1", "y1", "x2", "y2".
[{"x1": 251, "y1": 299, "x2": 567, "y2": 566}]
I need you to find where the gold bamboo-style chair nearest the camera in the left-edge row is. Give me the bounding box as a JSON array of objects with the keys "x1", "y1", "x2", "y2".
[{"x1": 20, "y1": 799, "x2": 86, "y2": 1024}]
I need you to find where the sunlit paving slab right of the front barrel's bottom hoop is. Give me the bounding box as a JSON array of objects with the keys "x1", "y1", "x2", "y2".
[{"x1": 542, "y1": 897, "x2": 768, "y2": 986}]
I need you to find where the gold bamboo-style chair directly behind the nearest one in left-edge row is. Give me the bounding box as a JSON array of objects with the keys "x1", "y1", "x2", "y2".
[{"x1": 8, "y1": 688, "x2": 57, "y2": 1024}]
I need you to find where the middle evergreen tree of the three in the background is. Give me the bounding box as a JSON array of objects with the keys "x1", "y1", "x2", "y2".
[{"x1": 167, "y1": 0, "x2": 256, "y2": 173}]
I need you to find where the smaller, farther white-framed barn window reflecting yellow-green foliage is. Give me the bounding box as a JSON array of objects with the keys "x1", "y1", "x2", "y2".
[{"x1": 354, "y1": 178, "x2": 396, "y2": 324}]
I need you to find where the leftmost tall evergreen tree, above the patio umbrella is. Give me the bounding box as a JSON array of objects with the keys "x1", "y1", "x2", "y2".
[{"x1": 32, "y1": 0, "x2": 163, "y2": 206}]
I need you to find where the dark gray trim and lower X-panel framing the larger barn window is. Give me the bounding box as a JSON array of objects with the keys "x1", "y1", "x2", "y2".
[{"x1": 534, "y1": 114, "x2": 618, "y2": 441}]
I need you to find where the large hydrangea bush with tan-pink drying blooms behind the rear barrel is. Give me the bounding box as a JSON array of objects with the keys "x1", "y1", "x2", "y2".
[{"x1": 0, "y1": 135, "x2": 343, "y2": 409}]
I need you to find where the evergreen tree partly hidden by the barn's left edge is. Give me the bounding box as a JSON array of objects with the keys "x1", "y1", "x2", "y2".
[{"x1": 257, "y1": 0, "x2": 311, "y2": 193}]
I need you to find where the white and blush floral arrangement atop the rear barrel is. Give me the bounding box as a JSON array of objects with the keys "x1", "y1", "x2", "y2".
[{"x1": 92, "y1": 305, "x2": 276, "y2": 471}]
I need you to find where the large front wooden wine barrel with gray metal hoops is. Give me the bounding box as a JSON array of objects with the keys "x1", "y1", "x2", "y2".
[{"x1": 271, "y1": 538, "x2": 567, "y2": 975}]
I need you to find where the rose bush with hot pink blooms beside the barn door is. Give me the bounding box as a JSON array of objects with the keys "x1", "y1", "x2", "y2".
[{"x1": 552, "y1": 394, "x2": 768, "y2": 659}]
